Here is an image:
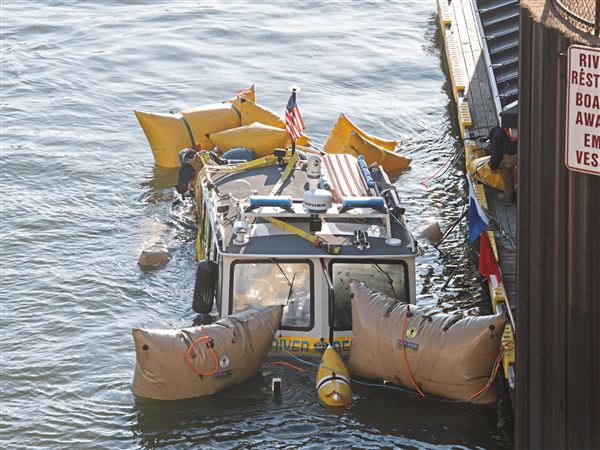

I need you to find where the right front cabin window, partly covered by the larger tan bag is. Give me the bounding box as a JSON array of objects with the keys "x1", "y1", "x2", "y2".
[{"x1": 330, "y1": 260, "x2": 409, "y2": 330}]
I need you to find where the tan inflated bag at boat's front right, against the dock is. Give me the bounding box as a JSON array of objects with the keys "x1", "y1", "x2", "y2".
[{"x1": 349, "y1": 281, "x2": 506, "y2": 403}]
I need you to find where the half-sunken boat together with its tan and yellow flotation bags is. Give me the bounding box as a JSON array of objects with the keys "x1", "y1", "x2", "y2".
[{"x1": 133, "y1": 86, "x2": 505, "y2": 406}]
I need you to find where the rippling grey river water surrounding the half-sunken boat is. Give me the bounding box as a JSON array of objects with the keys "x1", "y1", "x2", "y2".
[{"x1": 0, "y1": 0, "x2": 509, "y2": 449}]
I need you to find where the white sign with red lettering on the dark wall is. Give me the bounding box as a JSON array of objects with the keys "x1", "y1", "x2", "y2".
[{"x1": 565, "y1": 45, "x2": 600, "y2": 176}]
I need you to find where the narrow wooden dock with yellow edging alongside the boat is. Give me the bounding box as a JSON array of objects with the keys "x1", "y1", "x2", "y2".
[{"x1": 437, "y1": 0, "x2": 516, "y2": 388}]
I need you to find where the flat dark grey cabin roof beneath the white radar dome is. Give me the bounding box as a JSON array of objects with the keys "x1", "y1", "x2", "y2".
[{"x1": 206, "y1": 157, "x2": 417, "y2": 258}]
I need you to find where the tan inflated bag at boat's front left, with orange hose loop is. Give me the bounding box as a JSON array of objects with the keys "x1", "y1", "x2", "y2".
[{"x1": 132, "y1": 305, "x2": 283, "y2": 400}]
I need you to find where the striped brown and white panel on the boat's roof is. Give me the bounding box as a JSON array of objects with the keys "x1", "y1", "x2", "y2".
[{"x1": 321, "y1": 153, "x2": 371, "y2": 203}]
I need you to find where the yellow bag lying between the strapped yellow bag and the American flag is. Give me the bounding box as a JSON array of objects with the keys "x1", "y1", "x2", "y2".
[{"x1": 209, "y1": 122, "x2": 291, "y2": 158}]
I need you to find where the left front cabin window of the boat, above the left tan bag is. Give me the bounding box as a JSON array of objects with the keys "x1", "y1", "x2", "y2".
[{"x1": 230, "y1": 260, "x2": 313, "y2": 330}]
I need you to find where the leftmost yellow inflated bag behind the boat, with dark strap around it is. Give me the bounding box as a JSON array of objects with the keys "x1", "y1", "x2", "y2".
[{"x1": 135, "y1": 102, "x2": 241, "y2": 168}]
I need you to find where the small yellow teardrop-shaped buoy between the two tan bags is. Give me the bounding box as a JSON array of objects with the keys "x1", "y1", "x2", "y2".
[{"x1": 316, "y1": 345, "x2": 352, "y2": 406}]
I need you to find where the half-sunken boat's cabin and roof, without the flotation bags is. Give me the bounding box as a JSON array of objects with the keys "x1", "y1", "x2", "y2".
[{"x1": 194, "y1": 150, "x2": 417, "y2": 352}]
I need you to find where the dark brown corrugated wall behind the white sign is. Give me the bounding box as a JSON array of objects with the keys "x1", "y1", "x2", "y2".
[{"x1": 515, "y1": 0, "x2": 600, "y2": 450}]
